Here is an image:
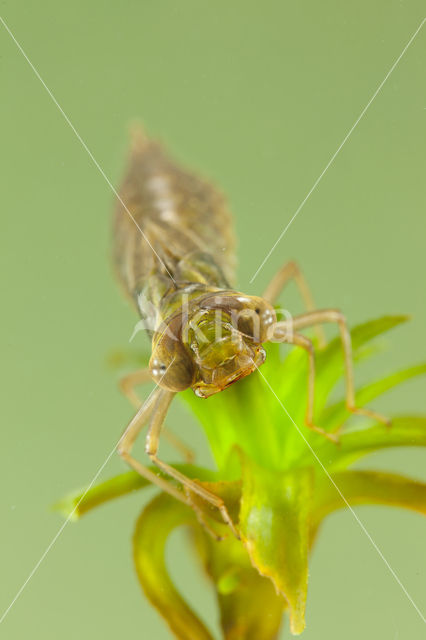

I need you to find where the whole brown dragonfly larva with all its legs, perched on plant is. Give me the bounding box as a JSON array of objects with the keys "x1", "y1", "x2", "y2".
[{"x1": 114, "y1": 130, "x2": 386, "y2": 530}]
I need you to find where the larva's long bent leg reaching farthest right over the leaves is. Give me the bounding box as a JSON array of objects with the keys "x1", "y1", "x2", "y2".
[{"x1": 277, "y1": 309, "x2": 390, "y2": 425}]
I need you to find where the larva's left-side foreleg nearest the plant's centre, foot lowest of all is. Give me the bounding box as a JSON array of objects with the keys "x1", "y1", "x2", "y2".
[{"x1": 145, "y1": 390, "x2": 239, "y2": 538}]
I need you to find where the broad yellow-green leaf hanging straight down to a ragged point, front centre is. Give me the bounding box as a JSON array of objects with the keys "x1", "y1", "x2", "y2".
[{"x1": 239, "y1": 456, "x2": 312, "y2": 634}]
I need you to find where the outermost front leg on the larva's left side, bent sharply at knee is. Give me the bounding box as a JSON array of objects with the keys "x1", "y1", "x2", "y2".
[{"x1": 117, "y1": 388, "x2": 188, "y2": 504}]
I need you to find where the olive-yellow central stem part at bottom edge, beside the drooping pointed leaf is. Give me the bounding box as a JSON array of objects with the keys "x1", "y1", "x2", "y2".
[{"x1": 196, "y1": 529, "x2": 285, "y2": 640}]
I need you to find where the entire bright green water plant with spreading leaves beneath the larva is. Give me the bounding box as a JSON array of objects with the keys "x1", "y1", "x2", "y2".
[{"x1": 58, "y1": 316, "x2": 426, "y2": 640}]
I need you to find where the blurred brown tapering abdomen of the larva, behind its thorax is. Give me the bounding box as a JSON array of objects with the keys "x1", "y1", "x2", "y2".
[{"x1": 114, "y1": 131, "x2": 234, "y2": 298}]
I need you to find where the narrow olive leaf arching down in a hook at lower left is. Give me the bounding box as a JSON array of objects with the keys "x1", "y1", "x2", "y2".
[{"x1": 133, "y1": 493, "x2": 213, "y2": 640}]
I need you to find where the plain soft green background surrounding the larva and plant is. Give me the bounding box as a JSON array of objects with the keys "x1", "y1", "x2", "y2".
[{"x1": 0, "y1": 0, "x2": 426, "y2": 640}]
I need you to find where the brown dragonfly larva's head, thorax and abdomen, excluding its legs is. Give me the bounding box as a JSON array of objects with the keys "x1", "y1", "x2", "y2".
[{"x1": 114, "y1": 133, "x2": 276, "y2": 397}]
